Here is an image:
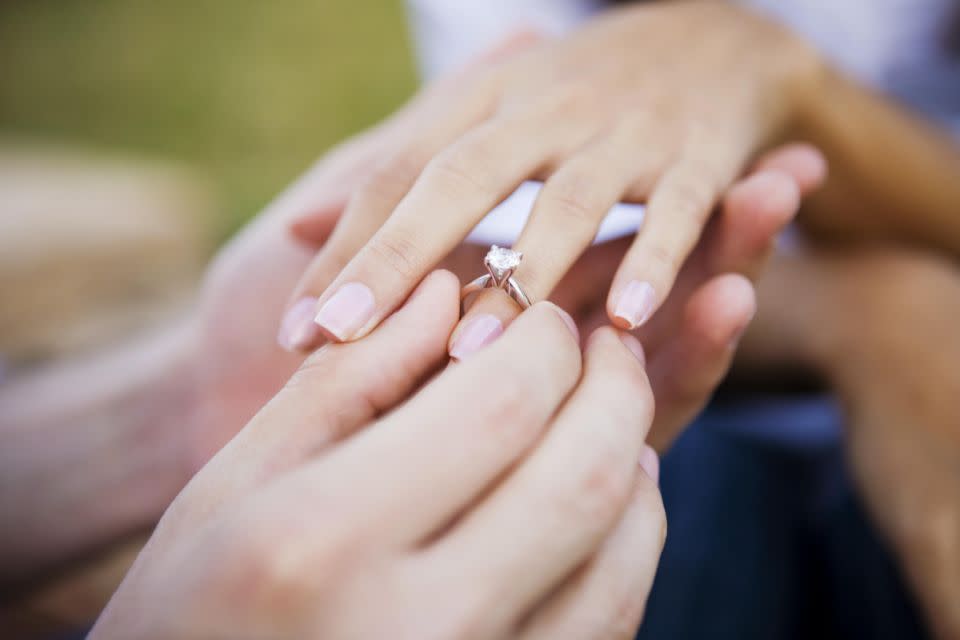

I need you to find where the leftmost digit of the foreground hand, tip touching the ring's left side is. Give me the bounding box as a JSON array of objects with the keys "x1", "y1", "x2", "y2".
[{"x1": 200, "y1": 271, "x2": 459, "y2": 504}]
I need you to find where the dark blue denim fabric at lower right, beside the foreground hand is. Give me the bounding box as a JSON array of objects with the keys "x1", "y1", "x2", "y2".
[{"x1": 637, "y1": 398, "x2": 928, "y2": 640}]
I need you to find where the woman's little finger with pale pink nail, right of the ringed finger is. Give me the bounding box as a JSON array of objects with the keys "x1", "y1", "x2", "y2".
[{"x1": 607, "y1": 143, "x2": 742, "y2": 329}]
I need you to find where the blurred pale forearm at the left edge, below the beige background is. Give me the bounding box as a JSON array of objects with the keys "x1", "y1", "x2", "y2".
[{"x1": 0, "y1": 330, "x2": 191, "y2": 584}]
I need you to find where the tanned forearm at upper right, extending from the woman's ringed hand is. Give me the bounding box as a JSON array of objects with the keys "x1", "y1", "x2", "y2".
[{"x1": 796, "y1": 71, "x2": 960, "y2": 255}]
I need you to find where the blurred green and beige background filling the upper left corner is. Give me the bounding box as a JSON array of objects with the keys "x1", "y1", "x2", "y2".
[{"x1": 0, "y1": 0, "x2": 415, "y2": 374}]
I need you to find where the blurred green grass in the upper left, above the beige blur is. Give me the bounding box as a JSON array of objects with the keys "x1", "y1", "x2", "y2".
[{"x1": 0, "y1": 0, "x2": 415, "y2": 236}]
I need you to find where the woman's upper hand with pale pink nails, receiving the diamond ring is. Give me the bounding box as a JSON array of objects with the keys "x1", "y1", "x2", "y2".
[{"x1": 282, "y1": 0, "x2": 819, "y2": 349}]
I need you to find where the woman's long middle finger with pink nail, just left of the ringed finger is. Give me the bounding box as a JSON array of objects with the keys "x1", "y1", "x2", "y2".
[{"x1": 308, "y1": 87, "x2": 592, "y2": 341}]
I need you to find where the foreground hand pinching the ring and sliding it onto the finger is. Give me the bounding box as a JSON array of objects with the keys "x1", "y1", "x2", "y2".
[{"x1": 97, "y1": 272, "x2": 664, "y2": 639}]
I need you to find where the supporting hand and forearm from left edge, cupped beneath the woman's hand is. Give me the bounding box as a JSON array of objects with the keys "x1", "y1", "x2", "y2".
[{"x1": 0, "y1": 127, "x2": 823, "y2": 585}]
